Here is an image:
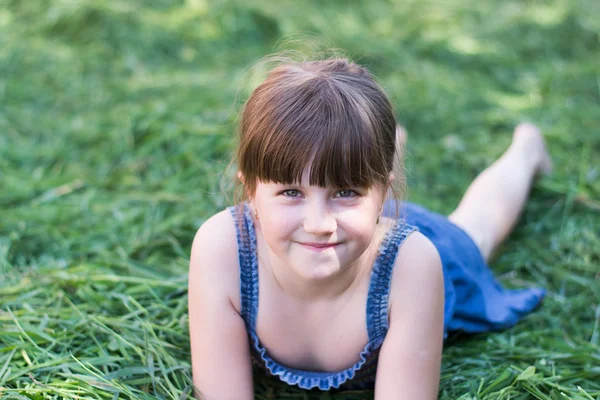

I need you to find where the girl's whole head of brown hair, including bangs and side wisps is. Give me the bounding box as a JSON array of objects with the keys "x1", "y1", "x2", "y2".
[{"x1": 236, "y1": 58, "x2": 404, "y2": 219}]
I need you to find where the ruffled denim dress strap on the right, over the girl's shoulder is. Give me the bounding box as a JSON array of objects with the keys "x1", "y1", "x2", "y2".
[{"x1": 367, "y1": 221, "x2": 417, "y2": 342}]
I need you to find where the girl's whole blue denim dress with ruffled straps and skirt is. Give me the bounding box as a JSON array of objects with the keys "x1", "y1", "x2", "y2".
[{"x1": 229, "y1": 202, "x2": 545, "y2": 390}]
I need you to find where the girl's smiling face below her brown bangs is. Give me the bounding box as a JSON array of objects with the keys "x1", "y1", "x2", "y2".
[{"x1": 252, "y1": 171, "x2": 384, "y2": 280}]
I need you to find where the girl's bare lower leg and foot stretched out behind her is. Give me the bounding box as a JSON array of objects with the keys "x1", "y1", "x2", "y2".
[{"x1": 448, "y1": 123, "x2": 552, "y2": 260}]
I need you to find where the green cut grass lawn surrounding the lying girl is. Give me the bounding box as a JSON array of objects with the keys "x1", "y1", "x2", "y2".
[{"x1": 0, "y1": 0, "x2": 600, "y2": 400}]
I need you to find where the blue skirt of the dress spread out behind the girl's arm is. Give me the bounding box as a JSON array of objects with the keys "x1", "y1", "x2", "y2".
[{"x1": 384, "y1": 202, "x2": 545, "y2": 333}]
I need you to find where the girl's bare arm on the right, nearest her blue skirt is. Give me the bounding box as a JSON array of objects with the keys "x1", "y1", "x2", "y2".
[{"x1": 375, "y1": 232, "x2": 444, "y2": 400}]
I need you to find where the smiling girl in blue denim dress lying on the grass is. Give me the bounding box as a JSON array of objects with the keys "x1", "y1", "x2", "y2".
[{"x1": 189, "y1": 59, "x2": 550, "y2": 400}]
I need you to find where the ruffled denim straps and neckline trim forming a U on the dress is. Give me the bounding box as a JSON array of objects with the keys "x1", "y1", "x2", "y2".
[{"x1": 230, "y1": 204, "x2": 416, "y2": 390}]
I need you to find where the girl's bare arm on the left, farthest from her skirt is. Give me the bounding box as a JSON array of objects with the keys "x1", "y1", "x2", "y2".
[{"x1": 188, "y1": 211, "x2": 254, "y2": 400}]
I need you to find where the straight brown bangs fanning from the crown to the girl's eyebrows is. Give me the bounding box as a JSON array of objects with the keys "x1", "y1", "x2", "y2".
[{"x1": 246, "y1": 78, "x2": 396, "y2": 188}]
